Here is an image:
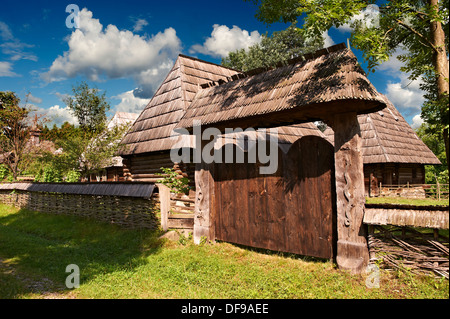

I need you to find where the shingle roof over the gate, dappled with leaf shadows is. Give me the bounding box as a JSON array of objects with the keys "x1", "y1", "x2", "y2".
[{"x1": 177, "y1": 44, "x2": 385, "y2": 128}]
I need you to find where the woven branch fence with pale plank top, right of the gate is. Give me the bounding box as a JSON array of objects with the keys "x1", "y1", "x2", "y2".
[{"x1": 364, "y1": 204, "x2": 449, "y2": 279}]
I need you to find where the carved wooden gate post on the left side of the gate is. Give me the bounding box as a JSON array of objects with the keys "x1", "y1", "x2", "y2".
[{"x1": 194, "y1": 141, "x2": 215, "y2": 244}]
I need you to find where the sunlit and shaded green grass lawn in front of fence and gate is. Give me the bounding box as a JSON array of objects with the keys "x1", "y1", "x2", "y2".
[{"x1": 0, "y1": 204, "x2": 449, "y2": 299}]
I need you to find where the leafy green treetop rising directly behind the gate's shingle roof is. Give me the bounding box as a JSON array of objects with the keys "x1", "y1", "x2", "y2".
[{"x1": 222, "y1": 24, "x2": 323, "y2": 72}]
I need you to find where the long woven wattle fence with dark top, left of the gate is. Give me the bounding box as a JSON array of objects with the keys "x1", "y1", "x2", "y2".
[{"x1": 0, "y1": 183, "x2": 160, "y2": 229}]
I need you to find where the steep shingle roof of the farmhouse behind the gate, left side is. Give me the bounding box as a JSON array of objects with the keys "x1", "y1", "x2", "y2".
[{"x1": 119, "y1": 55, "x2": 238, "y2": 156}]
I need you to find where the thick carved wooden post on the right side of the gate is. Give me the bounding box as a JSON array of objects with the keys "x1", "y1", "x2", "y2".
[{"x1": 330, "y1": 113, "x2": 369, "y2": 273}]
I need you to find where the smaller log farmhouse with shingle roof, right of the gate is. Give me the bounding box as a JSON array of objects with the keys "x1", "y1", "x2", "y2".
[{"x1": 324, "y1": 98, "x2": 441, "y2": 195}]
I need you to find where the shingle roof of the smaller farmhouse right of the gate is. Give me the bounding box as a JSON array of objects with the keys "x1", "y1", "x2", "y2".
[{"x1": 324, "y1": 97, "x2": 441, "y2": 165}]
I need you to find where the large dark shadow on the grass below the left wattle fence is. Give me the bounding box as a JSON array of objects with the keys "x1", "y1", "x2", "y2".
[{"x1": 0, "y1": 206, "x2": 163, "y2": 299}]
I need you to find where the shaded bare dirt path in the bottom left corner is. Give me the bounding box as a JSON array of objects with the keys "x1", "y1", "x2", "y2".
[{"x1": 0, "y1": 258, "x2": 74, "y2": 299}]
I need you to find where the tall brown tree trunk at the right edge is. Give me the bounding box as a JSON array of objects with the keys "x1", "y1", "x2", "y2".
[{"x1": 429, "y1": 0, "x2": 450, "y2": 167}]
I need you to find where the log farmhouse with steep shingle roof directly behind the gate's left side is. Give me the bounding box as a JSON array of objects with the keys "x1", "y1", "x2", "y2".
[{"x1": 120, "y1": 54, "x2": 322, "y2": 190}]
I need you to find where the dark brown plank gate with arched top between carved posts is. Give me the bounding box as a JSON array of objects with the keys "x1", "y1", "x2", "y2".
[{"x1": 213, "y1": 136, "x2": 336, "y2": 259}]
